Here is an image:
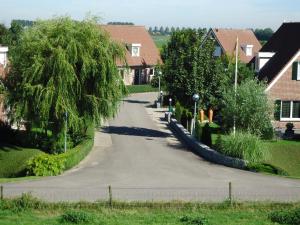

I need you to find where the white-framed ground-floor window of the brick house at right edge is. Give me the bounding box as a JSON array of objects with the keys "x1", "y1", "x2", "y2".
[{"x1": 280, "y1": 101, "x2": 300, "y2": 121}]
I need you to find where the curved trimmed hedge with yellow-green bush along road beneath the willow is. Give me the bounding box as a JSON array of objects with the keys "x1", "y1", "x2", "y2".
[{"x1": 27, "y1": 126, "x2": 95, "y2": 176}]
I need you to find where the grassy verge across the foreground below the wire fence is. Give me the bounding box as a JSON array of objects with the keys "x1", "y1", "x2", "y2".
[{"x1": 0, "y1": 196, "x2": 300, "y2": 225}]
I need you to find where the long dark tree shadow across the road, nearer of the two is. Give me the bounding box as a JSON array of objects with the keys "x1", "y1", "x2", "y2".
[{"x1": 103, "y1": 126, "x2": 170, "y2": 138}]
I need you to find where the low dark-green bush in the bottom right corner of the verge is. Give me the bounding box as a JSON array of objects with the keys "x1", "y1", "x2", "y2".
[{"x1": 269, "y1": 208, "x2": 300, "y2": 225}]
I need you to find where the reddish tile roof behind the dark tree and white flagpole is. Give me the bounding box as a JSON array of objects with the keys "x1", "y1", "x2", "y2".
[{"x1": 212, "y1": 29, "x2": 261, "y2": 63}]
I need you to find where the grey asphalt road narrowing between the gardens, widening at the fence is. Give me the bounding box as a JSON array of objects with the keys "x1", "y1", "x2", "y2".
[{"x1": 4, "y1": 93, "x2": 300, "y2": 201}]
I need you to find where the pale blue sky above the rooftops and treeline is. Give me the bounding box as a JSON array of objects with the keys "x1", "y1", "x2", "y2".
[{"x1": 0, "y1": 0, "x2": 300, "y2": 30}]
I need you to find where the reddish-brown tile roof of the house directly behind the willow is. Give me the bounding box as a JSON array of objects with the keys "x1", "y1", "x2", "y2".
[{"x1": 101, "y1": 25, "x2": 161, "y2": 66}]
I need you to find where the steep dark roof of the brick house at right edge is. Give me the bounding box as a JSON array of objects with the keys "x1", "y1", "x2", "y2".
[{"x1": 258, "y1": 23, "x2": 300, "y2": 83}]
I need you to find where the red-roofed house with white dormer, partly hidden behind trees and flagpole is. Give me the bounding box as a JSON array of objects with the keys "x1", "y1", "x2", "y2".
[{"x1": 207, "y1": 29, "x2": 261, "y2": 63}]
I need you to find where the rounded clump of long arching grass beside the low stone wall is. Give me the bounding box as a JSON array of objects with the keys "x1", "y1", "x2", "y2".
[{"x1": 219, "y1": 131, "x2": 268, "y2": 163}]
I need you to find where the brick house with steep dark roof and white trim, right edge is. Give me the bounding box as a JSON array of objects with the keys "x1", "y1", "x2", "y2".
[{"x1": 253, "y1": 23, "x2": 300, "y2": 129}]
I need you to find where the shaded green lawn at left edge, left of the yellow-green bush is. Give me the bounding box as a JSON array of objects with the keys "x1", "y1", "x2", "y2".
[{"x1": 0, "y1": 144, "x2": 42, "y2": 178}]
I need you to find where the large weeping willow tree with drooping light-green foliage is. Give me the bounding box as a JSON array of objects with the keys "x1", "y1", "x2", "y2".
[{"x1": 6, "y1": 17, "x2": 125, "y2": 151}]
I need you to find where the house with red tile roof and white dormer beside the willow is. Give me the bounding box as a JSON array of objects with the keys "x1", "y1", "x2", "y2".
[{"x1": 101, "y1": 25, "x2": 161, "y2": 85}]
